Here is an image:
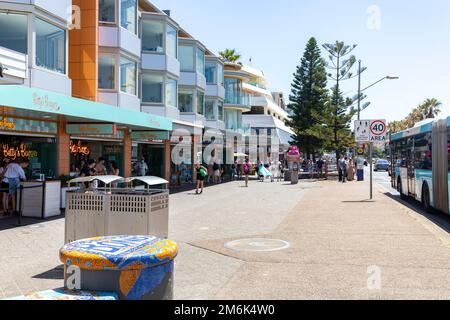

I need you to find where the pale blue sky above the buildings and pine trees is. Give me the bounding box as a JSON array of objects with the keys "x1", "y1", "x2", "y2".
[{"x1": 151, "y1": 0, "x2": 450, "y2": 120}]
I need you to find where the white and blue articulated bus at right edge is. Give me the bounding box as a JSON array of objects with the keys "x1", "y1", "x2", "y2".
[{"x1": 390, "y1": 117, "x2": 450, "y2": 214}]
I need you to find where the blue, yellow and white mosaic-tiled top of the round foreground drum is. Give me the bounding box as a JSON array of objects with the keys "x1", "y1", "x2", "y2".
[{"x1": 59, "y1": 236, "x2": 178, "y2": 271}]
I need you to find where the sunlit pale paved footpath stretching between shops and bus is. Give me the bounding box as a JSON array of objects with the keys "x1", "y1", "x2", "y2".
[{"x1": 0, "y1": 181, "x2": 450, "y2": 299}]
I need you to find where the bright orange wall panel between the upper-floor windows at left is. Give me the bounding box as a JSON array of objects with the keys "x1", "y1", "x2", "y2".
[{"x1": 69, "y1": 0, "x2": 99, "y2": 101}]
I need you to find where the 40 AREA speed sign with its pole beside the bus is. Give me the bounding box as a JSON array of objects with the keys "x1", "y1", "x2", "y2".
[{"x1": 355, "y1": 120, "x2": 387, "y2": 200}]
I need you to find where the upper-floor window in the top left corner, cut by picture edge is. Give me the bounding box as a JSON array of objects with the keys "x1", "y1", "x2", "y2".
[{"x1": 0, "y1": 12, "x2": 28, "y2": 54}]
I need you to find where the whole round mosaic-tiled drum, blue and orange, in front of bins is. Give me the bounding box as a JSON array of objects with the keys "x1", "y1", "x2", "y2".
[{"x1": 60, "y1": 236, "x2": 178, "y2": 300}]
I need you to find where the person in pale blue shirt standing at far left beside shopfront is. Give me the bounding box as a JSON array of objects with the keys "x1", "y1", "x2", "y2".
[{"x1": 0, "y1": 158, "x2": 29, "y2": 216}]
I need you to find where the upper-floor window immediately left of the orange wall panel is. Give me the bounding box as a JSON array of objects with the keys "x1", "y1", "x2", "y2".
[{"x1": 36, "y1": 18, "x2": 66, "y2": 73}]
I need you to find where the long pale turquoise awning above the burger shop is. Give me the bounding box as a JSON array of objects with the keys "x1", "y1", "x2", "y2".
[{"x1": 0, "y1": 85, "x2": 172, "y2": 131}]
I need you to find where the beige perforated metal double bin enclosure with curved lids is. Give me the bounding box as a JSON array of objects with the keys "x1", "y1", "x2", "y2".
[{"x1": 65, "y1": 176, "x2": 169, "y2": 243}]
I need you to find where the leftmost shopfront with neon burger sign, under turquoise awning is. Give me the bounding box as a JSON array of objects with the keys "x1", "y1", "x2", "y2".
[{"x1": 0, "y1": 117, "x2": 58, "y2": 180}]
